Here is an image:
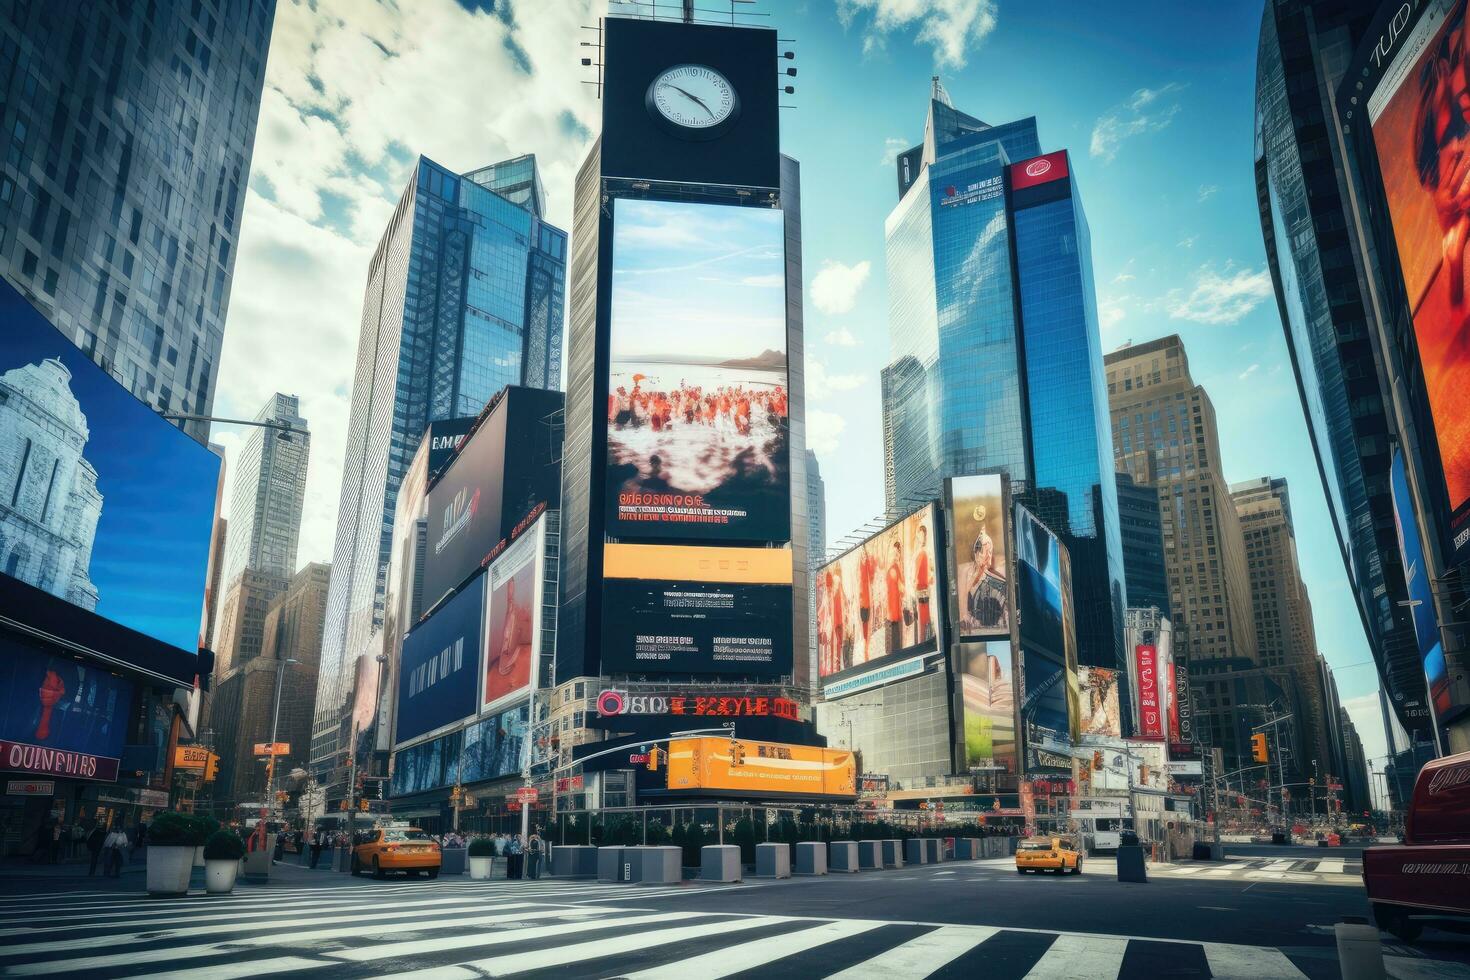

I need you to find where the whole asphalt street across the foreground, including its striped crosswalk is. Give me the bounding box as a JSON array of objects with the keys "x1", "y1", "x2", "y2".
[{"x1": 0, "y1": 846, "x2": 1470, "y2": 980}]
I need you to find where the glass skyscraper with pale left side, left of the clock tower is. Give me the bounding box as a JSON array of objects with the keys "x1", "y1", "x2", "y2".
[{"x1": 312, "y1": 156, "x2": 567, "y2": 782}]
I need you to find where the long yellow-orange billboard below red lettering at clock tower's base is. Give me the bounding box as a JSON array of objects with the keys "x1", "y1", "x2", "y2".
[{"x1": 667, "y1": 738, "x2": 857, "y2": 799}]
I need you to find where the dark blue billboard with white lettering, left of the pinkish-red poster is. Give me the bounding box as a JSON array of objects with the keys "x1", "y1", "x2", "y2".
[{"x1": 394, "y1": 582, "x2": 485, "y2": 743}]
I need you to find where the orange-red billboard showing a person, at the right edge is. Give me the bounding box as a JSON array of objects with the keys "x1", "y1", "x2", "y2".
[{"x1": 1367, "y1": 0, "x2": 1470, "y2": 564}]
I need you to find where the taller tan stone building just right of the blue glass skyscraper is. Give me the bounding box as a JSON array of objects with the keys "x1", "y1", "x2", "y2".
[{"x1": 1105, "y1": 335, "x2": 1255, "y2": 671}]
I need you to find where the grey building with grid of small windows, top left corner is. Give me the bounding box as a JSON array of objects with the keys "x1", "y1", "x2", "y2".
[{"x1": 0, "y1": 0, "x2": 275, "y2": 441}]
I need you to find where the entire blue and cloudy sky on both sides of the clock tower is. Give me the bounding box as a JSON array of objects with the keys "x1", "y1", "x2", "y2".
[{"x1": 215, "y1": 0, "x2": 1385, "y2": 793}]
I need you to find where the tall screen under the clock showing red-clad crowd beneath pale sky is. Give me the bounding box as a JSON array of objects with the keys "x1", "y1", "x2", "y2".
[{"x1": 606, "y1": 198, "x2": 791, "y2": 542}]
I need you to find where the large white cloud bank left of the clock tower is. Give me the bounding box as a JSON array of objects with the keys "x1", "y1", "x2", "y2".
[{"x1": 215, "y1": 0, "x2": 603, "y2": 563}]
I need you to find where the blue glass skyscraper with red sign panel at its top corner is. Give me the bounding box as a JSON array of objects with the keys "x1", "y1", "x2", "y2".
[{"x1": 883, "y1": 79, "x2": 1127, "y2": 667}]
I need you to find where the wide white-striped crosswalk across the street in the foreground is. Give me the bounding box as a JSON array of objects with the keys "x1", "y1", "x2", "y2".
[{"x1": 0, "y1": 880, "x2": 1307, "y2": 980}]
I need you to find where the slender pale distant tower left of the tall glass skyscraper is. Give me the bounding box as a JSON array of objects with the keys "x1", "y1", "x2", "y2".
[{"x1": 215, "y1": 392, "x2": 312, "y2": 646}]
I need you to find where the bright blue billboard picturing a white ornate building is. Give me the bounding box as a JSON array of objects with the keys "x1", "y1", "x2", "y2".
[{"x1": 0, "y1": 282, "x2": 221, "y2": 654}]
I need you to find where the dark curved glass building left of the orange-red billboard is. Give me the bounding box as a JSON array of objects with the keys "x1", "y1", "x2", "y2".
[{"x1": 1255, "y1": 0, "x2": 1429, "y2": 738}]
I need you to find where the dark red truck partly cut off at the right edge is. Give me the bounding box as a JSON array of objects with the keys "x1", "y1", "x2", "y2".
[{"x1": 1363, "y1": 752, "x2": 1470, "y2": 942}]
